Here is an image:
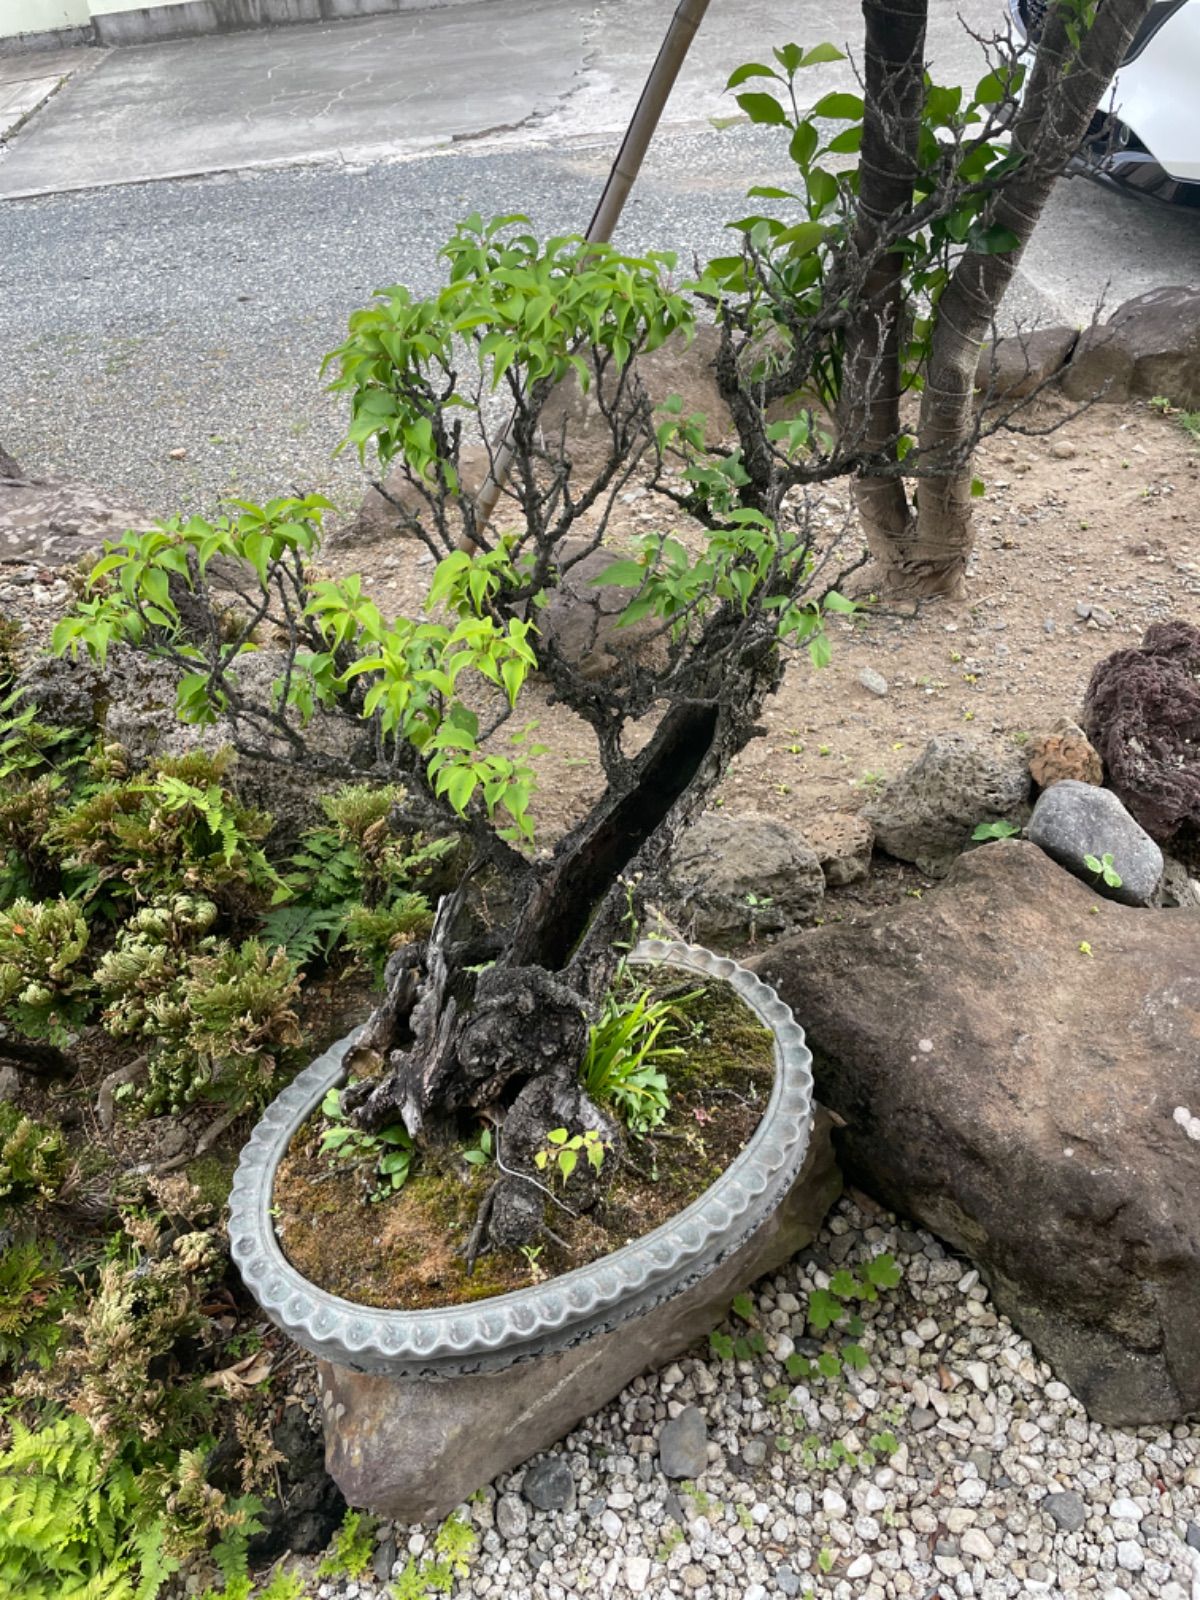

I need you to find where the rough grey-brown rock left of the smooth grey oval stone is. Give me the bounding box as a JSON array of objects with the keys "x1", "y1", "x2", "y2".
[{"x1": 862, "y1": 733, "x2": 1029, "y2": 877}]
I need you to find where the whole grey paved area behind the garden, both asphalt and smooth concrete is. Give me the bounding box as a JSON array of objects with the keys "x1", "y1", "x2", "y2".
[{"x1": 0, "y1": 0, "x2": 1200, "y2": 514}]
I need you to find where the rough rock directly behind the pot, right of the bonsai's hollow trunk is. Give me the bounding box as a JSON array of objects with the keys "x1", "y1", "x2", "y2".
[{"x1": 667, "y1": 811, "x2": 826, "y2": 946}]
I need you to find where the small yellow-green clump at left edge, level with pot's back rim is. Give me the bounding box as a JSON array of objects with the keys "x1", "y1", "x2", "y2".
[{"x1": 0, "y1": 896, "x2": 94, "y2": 1045}]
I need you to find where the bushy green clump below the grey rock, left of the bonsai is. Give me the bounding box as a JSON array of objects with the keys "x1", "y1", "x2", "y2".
[{"x1": 45, "y1": 750, "x2": 280, "y2": 907}]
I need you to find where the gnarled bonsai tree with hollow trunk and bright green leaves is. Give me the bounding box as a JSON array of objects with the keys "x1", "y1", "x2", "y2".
[{"x1": 56, "y1": 218, "x2": 850, "y2": 1245}]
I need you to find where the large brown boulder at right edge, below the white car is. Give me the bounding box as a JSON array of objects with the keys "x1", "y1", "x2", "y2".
[{"x1": 1062, "y1": 288, "x2": 1200, "y2": 406}]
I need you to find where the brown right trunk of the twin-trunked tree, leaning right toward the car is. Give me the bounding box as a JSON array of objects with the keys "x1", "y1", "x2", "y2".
[{"x1": 908, "y1": 0, "x2": 1150, "y2": 595}]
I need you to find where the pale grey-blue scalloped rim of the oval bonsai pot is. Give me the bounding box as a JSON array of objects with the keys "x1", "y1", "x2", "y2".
[{"x1": 229, "y1": 939, "x2": 813, "y2": 1378}]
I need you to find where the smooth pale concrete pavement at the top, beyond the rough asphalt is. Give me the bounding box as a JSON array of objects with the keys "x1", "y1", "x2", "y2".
[{"x1": 0, "y1": 0, "x2": 998, "y2": 197}]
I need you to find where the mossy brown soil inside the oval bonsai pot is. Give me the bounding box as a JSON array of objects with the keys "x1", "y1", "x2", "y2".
[{"x1": 274, "y1": 974, "x2": 774, "y2": 1310}]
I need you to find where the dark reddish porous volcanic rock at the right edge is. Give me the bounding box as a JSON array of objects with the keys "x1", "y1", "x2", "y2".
[{"x1": 1083, "y1": 622, "x2": 1200, "y2": 845}]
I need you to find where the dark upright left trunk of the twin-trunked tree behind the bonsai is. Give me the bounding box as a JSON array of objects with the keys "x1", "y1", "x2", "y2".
[{"x1": 840, "y1": 0, "x2": 928, "y2": 570}]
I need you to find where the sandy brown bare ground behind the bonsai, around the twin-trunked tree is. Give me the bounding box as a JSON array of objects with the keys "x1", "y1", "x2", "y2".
[{"x1": 330, "y1": 395, "x2": 1200, "y2": 870}]
